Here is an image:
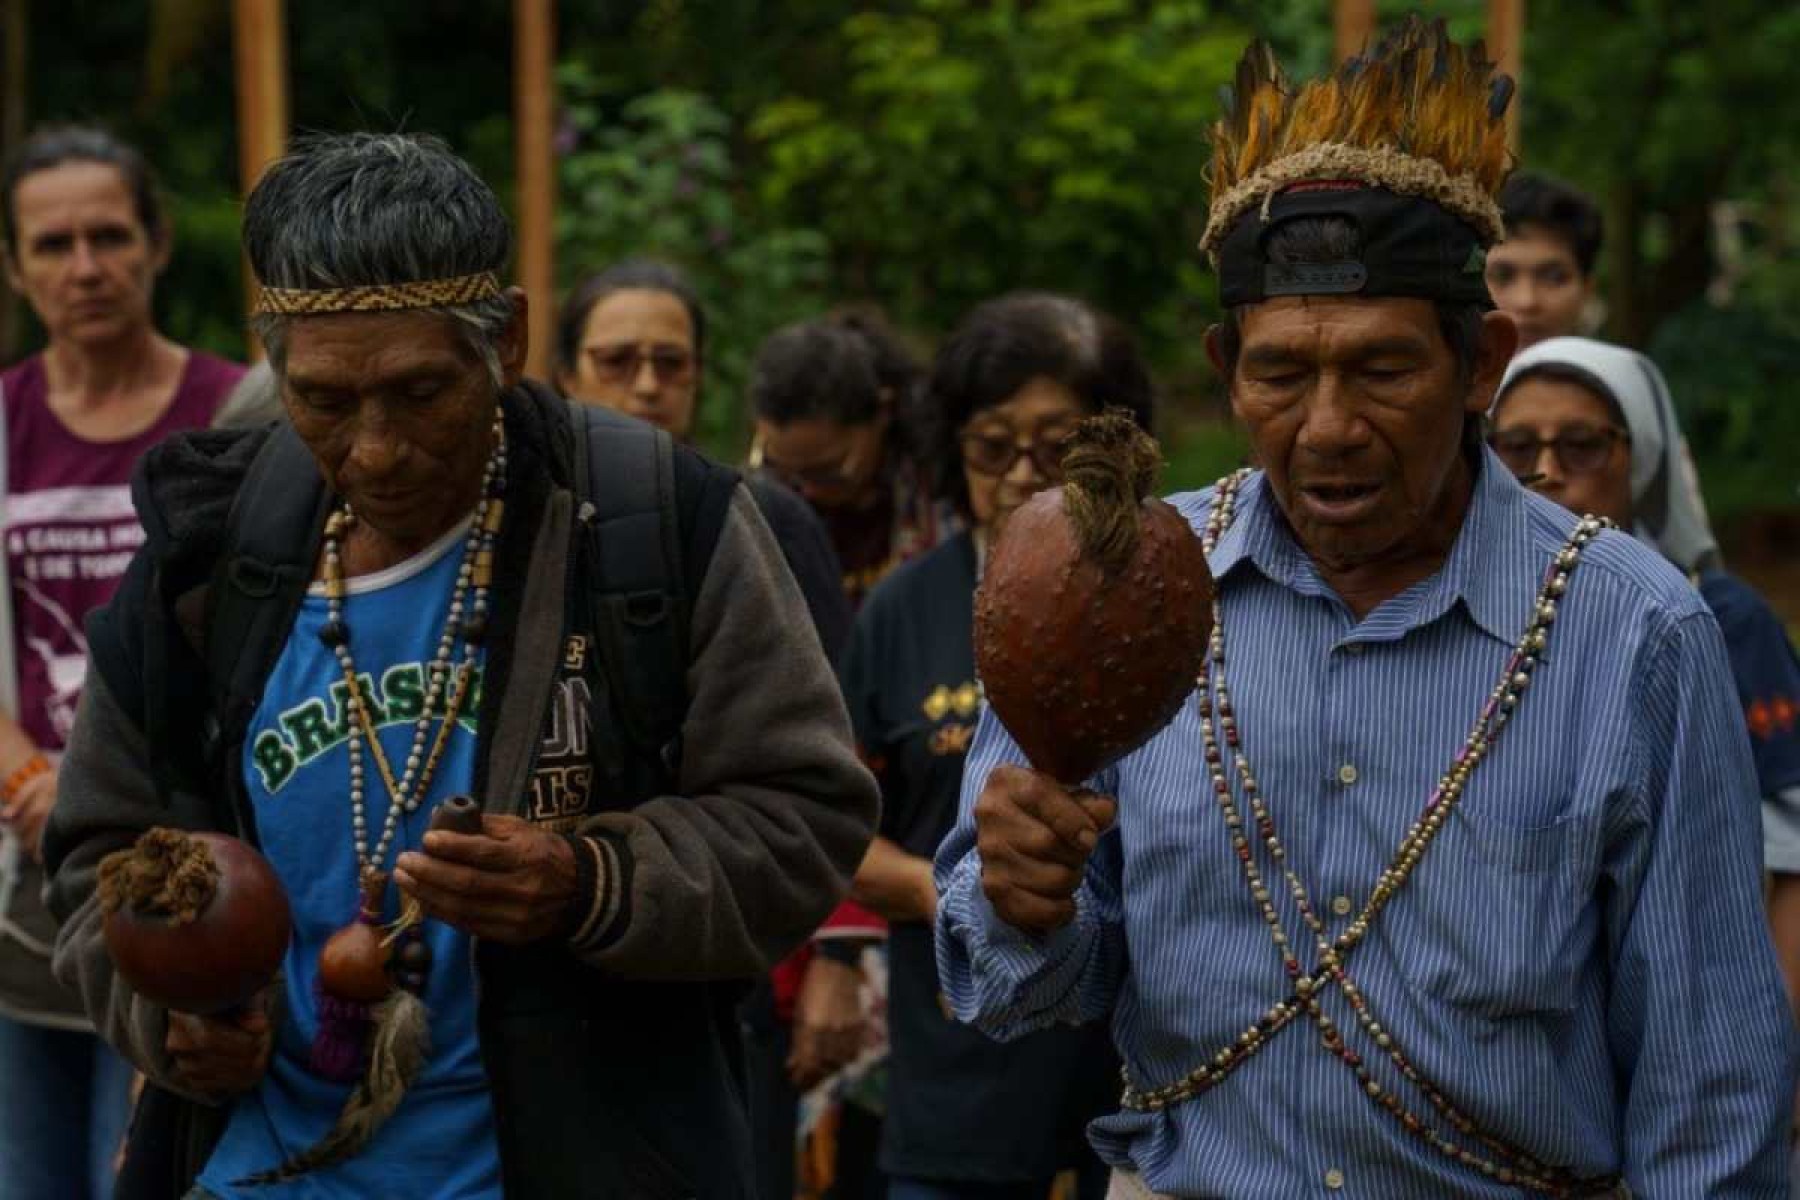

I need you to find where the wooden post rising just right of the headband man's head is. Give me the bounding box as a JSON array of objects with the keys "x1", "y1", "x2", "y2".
[{"x1": 513, "y1": 0, "x2": 556, "y2": 380}]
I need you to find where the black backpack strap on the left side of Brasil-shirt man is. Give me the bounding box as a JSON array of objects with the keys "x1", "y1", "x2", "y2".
[{"x1": 202, "y1": 423, "x2": 331, "y2": 788}]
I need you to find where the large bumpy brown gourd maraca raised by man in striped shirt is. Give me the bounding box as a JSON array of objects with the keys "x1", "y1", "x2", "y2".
[{"x1": 974, "y1": 412, "x2": 1213, "y2": 788}]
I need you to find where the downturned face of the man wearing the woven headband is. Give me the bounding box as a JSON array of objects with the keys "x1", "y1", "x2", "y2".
[{"x1": 281, "y1": 300, "x2": 526, "y2": 552}]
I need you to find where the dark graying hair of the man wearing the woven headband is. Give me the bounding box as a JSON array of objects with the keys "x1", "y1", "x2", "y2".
[{"x1": 243, "y1": 133, "x2": 513, "y2": 385}]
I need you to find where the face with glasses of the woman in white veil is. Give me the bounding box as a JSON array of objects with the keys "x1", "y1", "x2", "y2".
[{"x1": 1489, "y1": 376, "x2": 1631, "y2": 529}]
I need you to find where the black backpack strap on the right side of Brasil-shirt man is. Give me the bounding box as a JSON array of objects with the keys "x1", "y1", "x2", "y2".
[{"x1": 571, "y1": 405, "x2": 693, "y2": 775}]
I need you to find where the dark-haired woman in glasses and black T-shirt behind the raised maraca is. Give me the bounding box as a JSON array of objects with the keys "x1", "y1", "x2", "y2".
[{"x1": 842, "y1": 293, "x2": 1154, "y2": 1200}]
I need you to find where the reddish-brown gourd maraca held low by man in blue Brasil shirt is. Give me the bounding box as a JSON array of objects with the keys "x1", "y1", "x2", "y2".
[{"x1": 99, "y1": 828, "x2": 292, "y2": 1015}]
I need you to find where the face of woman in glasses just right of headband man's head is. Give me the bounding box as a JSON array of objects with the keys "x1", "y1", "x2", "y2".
[{"x1": 563, "y1": 288, "x2": 700, "y2": 439}]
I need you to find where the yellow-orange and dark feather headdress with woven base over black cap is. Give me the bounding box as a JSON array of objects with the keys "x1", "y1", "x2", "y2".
[{"x1": 1201, "y1": 16, "x2": 1512, "y2": 257}]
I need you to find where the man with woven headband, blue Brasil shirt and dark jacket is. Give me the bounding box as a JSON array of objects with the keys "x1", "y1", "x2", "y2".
[{"x1": 38, "y1": 135, "x2": 877, "y2": 1198}]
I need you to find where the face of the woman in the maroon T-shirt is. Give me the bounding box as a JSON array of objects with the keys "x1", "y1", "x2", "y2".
[{"x1": 7, "y1": 162, "x2": 169, "y2": 345}]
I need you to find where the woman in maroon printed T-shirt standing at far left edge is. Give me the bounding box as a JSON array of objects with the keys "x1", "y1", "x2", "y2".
[{"x1": 0, "y1": 128, "x2": 243, "y2": 1200}]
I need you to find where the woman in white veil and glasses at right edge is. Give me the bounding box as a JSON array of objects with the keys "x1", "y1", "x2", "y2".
[{"x1": 1489, "y1": 338, "x2": 1800, "y2": 1043}]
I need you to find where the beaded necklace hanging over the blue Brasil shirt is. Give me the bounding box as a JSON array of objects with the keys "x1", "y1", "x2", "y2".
[{"x1": 319, "y1": 414, "x2": 506, "y2": 887}]
